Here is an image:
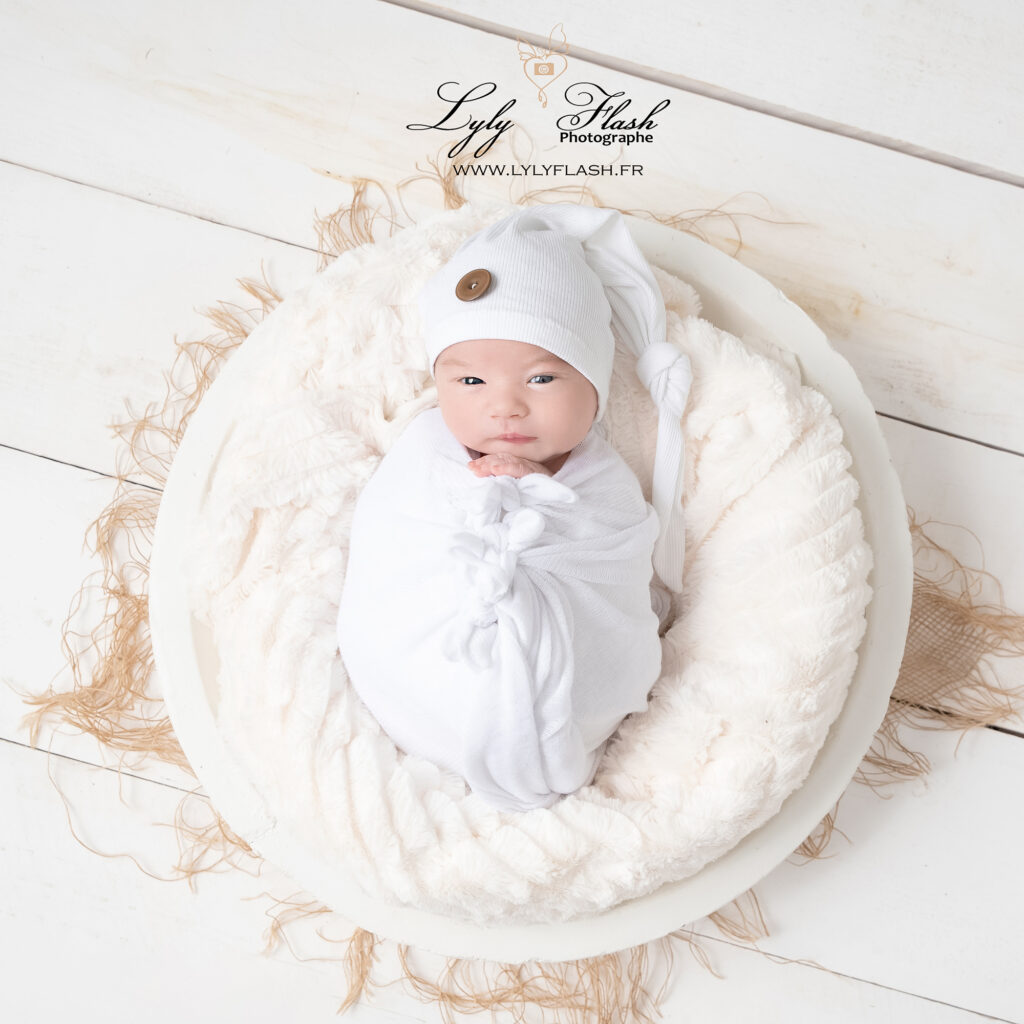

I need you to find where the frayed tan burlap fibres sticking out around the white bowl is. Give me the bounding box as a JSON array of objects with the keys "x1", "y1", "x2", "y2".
[{"x1": 26, "y1": 160, "x2": 1024, "y2": 1024}]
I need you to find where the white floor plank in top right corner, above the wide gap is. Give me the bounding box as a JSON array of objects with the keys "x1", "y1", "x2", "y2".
[{"x1": 423, "y1": 0, "x2": 1024, "y2": 178}]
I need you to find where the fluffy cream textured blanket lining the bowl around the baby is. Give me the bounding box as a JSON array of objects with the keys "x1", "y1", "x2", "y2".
[{"x1": 188, "y1": 207, "x2": 871, "y2": 922}]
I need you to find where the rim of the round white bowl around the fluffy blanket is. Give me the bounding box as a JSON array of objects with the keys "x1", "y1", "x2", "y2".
[{"x1": 150, "y1": 217, "x2": 913, "y2": 963}]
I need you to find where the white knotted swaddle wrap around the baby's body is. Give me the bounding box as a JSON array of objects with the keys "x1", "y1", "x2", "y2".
[{"x1": 338, "y1": 409, "x2": 662, "y2": 810}]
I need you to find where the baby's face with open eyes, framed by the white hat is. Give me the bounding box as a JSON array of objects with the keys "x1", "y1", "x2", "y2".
[{"x1": 434, "y1": 338, "x2": 597, "y2": 472}]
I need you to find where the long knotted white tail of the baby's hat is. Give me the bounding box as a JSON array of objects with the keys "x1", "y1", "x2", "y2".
[{"x1": 522, "y1": 205, "x2": 693, "y2": 593}]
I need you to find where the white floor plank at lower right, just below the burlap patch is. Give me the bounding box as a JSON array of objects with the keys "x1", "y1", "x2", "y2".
[{"x1": 701, "y1": 729, "x2": 1024, "y2": 1020}]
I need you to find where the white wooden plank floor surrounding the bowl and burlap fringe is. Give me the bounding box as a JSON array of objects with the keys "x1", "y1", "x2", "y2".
[{"x1": 0, "y1": 0, "x2": 1024, "y2": 1024}]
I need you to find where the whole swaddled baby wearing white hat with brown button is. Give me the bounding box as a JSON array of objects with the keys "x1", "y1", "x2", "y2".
[{"x1": 338, "y1": 205, "x2": 690, "y2": 811}]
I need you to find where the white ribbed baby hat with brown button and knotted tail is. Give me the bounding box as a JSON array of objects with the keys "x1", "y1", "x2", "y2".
[{"x1": 420, "y1": 203, "x2": 691, "y2": 592}]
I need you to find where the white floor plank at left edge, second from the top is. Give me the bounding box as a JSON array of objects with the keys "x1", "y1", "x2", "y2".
[{"x1": 0, "y1": 165, "x2": 316, "y2": 473}]
